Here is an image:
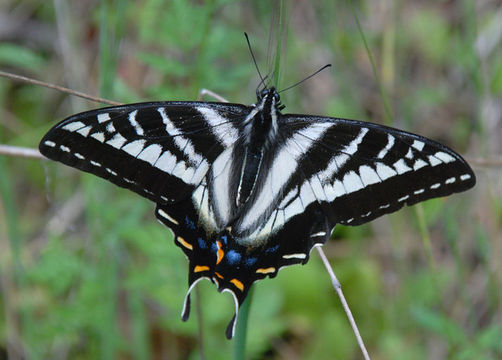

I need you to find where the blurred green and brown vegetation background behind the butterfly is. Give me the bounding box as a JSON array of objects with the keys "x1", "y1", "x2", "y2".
[{"x1": 0, "y1": 0, "x2": 502, "y2": 360}]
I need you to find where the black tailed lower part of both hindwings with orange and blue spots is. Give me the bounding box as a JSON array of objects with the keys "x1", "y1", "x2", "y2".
[{"x1": 155, "y1": 199, "x2": 330, "y2": 338}]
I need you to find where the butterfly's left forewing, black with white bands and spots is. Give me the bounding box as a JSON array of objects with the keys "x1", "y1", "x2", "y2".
[{"x1": 39, "y1": 102, "x2": 249, "y2": 204}]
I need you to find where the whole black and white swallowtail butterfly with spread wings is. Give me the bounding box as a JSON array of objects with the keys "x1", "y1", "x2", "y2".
[{"x1": 40, "y1": 83, "x2": 476, "y2": 338}]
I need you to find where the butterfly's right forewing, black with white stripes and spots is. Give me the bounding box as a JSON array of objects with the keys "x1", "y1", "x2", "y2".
[{"x1": 260, "y1": 115, "x2": 475, "y2": 231}]
